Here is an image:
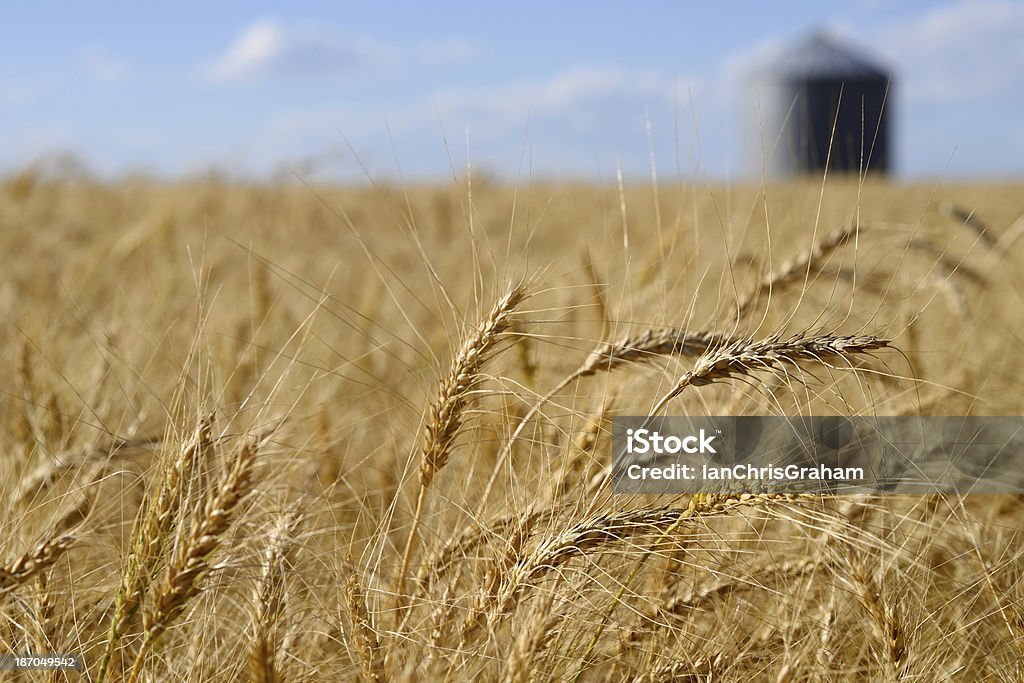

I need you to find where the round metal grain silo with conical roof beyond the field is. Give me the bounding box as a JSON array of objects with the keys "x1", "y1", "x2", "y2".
[{"x1": 754, "y1": 32, "x2": 892, "y2": 176}]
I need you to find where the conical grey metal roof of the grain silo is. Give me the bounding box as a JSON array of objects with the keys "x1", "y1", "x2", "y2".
[{"x1": 762, "y1": 31, "x2": 889, "y2": 80}]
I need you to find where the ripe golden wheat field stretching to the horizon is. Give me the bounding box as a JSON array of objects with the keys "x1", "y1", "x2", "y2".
[{"x1": 0, "y1": 173, "x2": 1024, "y2": 682}]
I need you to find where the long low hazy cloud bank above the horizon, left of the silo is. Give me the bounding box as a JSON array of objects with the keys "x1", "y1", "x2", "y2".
[{"x1": 245, "y1": 66, "x2": 717, "y2": 175}]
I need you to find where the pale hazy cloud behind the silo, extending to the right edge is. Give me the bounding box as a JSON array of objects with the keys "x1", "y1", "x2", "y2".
[{"x1": 719, "y1": 0, "x2": 1024, "y2": 174}]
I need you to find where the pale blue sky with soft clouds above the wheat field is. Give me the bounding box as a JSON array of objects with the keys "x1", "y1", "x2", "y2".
[{"x1": 0, "y1": 0, "x2": 1024, "y2": 179}]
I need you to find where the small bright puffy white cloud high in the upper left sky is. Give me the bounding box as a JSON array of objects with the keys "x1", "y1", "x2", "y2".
[{"x1": 204, "y1": 19, "x2": 398, "y2": 82}]
